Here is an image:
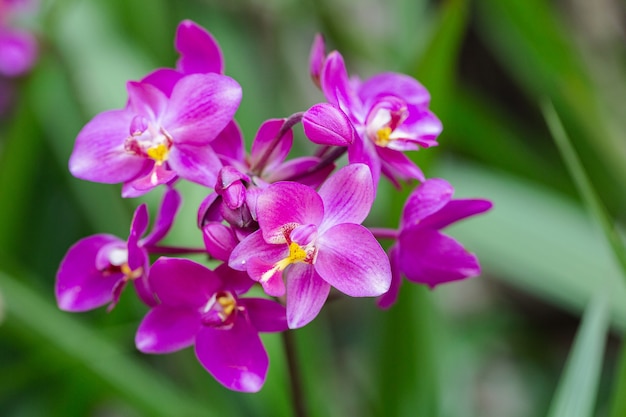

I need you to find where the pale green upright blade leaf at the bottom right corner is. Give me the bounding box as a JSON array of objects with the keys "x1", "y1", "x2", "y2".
[{"x1": 548, "y1": 291, "x2": 609, "y2": 417}]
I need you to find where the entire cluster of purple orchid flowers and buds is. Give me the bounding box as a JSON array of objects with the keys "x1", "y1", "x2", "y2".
[{"x1": 56, "y1": 20, "x2": 491, "y2": 392}]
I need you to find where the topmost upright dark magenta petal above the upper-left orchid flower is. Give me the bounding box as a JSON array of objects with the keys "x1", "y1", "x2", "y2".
[{"x1": 175, "y1": 20, "x2": 224, "y2": 74}]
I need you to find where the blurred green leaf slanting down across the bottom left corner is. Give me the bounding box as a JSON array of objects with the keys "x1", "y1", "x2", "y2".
[{"x1": 0, "y1": 272, "x2": 217, "y2": 417}]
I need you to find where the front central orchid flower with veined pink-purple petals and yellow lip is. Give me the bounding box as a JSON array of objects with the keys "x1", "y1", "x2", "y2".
[{"x1": 229, "y1": 164, "x2": 391, "y2": 328}]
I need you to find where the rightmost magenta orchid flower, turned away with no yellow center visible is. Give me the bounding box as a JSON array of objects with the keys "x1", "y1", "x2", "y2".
[{"x1": 378, "y1": 178, "x2": 493, "y2": 308}]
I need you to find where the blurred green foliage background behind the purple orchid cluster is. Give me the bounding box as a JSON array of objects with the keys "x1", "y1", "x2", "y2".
[{"x1": 0, "y1": 0, "x2": 626, "y2": 417}]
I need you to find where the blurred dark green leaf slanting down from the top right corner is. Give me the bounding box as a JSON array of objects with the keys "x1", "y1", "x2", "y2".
[{"x1": 476, "y1": 0, "x2": 626, "y2": 210}]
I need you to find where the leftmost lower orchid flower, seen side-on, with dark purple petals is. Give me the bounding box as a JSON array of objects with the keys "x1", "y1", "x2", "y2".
[{"x1": 55, "y1": 189, "x2": 180, "y2": 312}]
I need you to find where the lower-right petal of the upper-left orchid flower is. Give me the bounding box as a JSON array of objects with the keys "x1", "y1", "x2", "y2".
[{"x1": 168, "y1": 144, "x2": 222, "y2": 188}]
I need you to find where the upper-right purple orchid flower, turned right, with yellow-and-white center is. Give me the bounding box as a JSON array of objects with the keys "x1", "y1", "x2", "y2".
[{"x1": 310, "y1": 37, "x2": 442, "y2": 186}]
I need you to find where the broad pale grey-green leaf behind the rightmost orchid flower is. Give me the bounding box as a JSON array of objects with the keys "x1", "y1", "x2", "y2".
[{"x1": 436, "y1": 160, "x2": 626, "y2": 329}]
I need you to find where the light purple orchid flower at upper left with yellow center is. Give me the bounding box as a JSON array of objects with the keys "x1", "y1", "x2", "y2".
[{"x1": 69, "y1": 74, "x2": 241, "y2": 197}]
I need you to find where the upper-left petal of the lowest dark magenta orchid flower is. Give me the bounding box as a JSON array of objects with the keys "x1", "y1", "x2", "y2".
[{"x1": 149, "y1": 257, "x2": 223, "y2": 307}]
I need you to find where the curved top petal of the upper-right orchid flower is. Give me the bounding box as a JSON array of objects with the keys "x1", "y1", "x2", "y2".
[{"x1": 359, "y1": 72, "x2": 430, "y2": 106}]
